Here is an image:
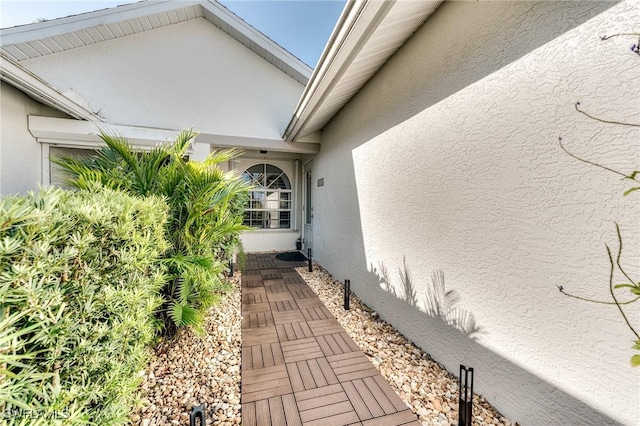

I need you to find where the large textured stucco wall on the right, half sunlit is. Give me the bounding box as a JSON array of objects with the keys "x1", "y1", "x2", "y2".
[{"x1": 314, "y1": 2, "x2": 640, "y2": 425}]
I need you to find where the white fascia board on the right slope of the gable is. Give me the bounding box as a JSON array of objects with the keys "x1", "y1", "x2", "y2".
[{"x1": 200, "y1": 1, "x2": 313, "y2": 78}]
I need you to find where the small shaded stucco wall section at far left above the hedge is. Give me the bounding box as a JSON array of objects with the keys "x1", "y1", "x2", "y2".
[{"x1": 0, "y1": 82, "x2": 69, "y2": 195}]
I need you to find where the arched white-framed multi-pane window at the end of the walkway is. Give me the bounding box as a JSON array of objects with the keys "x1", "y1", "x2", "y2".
[{"x1": 242, "y1": 163, "x2": 292, "y2": 229}]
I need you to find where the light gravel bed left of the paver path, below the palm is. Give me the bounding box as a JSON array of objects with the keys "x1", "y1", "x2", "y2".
[{"x1": 131, "y1": 274, "x2": 241, "y2": 426}]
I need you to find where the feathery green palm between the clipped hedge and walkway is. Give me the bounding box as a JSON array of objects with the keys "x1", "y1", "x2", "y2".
[{"x1": 54, "y1": 130, "x2": 250, "y2": 335}]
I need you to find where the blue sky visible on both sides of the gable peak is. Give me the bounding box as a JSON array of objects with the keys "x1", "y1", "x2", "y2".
[{"x1": 0, "y1": 0, "x2": 345, "y2": 67}]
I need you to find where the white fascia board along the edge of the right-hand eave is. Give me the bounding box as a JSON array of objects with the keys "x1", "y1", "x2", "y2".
[{"x1": 283, "y1": 0, "x2": 395, "y2": 141}]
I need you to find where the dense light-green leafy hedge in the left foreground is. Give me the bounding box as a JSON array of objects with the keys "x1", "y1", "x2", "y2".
[{"x1": 0, "y1": 187, "x2": 168, "y2": 425}]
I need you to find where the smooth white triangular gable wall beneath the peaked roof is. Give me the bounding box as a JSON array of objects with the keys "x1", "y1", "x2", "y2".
[{"x1": 21, "y1": 18, "x2": 304, "y2": 139}]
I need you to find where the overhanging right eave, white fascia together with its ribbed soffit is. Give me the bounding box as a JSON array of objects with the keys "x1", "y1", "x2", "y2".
[{"x1": 284, "y1": 0, "x2": 443, "y2": 141}]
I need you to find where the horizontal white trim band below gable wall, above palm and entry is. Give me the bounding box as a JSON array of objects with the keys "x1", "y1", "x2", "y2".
[{"x1": 29, "y1": 115, "x2": 320, "y2": 154}]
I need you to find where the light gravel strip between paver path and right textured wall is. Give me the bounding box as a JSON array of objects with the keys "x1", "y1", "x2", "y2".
[{"x1": 296, "y1": 263, "x2": 517, "y2": 426}]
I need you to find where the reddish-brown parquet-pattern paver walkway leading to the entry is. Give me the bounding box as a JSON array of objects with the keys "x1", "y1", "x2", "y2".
[{"x1": 242, "y1": 254, "x2": 420, "y2": 426}]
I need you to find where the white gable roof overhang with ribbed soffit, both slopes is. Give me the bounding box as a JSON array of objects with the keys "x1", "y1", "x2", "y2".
[{"x1": 0, "y1": 0, "x2": 311, "y2": 84}]
